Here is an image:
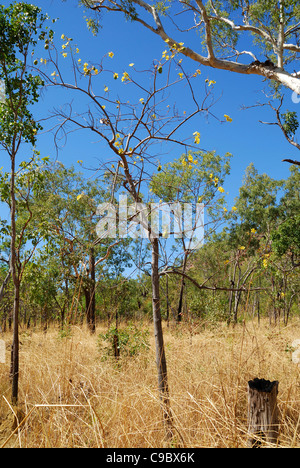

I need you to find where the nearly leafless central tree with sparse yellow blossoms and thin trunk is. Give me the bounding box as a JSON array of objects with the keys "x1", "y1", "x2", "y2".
[{"x1": 32, "y1": 28, "x2": 228, "y2": 436}]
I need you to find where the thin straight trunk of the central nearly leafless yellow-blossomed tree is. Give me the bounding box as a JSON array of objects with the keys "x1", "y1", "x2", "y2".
[{"x1": 151, "y1": 238, "x2": 173, "y2": 438}]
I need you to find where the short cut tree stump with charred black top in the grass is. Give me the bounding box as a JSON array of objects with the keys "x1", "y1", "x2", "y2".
[{"x1": 248, "y1": 378, "x2": 279, "y2": 448}]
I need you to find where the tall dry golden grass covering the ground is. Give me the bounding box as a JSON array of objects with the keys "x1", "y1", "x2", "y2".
[{"x1": 0, "y1": 320, "x2": 300, "y2": 448}]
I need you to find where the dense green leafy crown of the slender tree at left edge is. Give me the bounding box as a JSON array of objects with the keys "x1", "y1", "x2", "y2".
[{"x1": 0, "y1": 2, "x2": 53, "y2": 148}]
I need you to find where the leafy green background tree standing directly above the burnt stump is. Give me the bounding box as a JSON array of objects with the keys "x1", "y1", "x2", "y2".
[{"x1": 228, "y1": 163, "x2": 284, "y2": 323}]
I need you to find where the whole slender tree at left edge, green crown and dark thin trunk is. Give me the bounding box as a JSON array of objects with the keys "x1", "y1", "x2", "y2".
[{"x1": 0, "y1": 2, "x2": 52, "y2": 403}]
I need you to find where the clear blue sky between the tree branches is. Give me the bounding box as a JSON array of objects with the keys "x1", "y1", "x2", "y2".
[{"x1": 0, "y1": 0, "x2": 299, "y2": 205}]
